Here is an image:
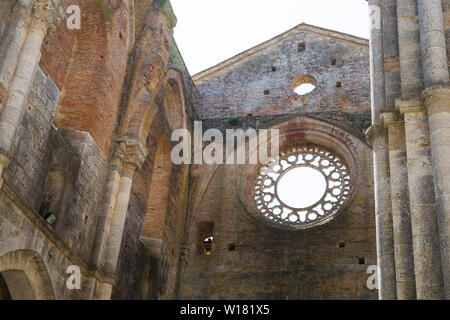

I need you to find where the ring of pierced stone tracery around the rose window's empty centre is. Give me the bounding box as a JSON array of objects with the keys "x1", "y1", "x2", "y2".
[{"x1": 255, "y1": 145, "x2": 352, "y2": 230}]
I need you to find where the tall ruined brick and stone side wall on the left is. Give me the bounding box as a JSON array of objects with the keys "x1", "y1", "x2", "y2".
[{"x1": 0, "y1": 0, "x2": 196, "y2": 299}]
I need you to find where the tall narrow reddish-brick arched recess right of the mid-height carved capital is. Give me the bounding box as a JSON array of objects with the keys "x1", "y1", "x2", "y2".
[{"x1": 143, "y1": 136, "x2": 172, "y2": 240}]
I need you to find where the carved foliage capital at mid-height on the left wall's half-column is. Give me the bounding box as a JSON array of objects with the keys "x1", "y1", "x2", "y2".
[{"x1": 112, "y1": 136, "x2": 147, "y2": 169}]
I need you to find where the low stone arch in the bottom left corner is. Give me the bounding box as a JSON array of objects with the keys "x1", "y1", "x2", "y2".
[{"x1": 0, "y1": 250, "x2": 55, "y2": 300}]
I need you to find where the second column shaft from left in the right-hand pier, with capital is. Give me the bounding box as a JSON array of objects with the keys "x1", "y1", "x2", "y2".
[{"x1": 383, "y1": 112, "x2": 416, "y2": 300}]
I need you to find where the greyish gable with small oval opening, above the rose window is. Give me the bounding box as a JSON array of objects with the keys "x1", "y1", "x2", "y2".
[{"x1": 193, "y1": 25, "x2": 370, "y2": 138}]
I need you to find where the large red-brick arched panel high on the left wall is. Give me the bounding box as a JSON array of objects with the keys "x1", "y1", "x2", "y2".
[{"x1": 53, "y1": 0, "x2": 133, "y2": 154}]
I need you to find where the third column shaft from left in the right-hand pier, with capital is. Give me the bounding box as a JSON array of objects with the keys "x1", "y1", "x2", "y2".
[{"x1": 398, "y1": 100, "x2": 443, "y2": 300}]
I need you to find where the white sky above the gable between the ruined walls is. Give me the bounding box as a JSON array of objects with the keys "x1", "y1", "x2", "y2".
[{"x1": 171, "y1": 0, "x2": 369, "y2": 75}]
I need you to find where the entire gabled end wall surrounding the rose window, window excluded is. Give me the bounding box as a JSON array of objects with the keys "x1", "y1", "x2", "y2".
[{"x1": 180, "y1": 25, "x2": 377, "y2": 299}]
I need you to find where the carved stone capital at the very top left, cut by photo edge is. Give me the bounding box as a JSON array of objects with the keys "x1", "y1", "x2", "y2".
[{"x1": 31, "y1": 0, "x2": 65, "y2": 34}]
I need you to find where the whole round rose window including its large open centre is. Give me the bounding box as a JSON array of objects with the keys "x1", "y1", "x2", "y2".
[{"x1": 255, "y1": 145, "x2": 352, "y2": 230}]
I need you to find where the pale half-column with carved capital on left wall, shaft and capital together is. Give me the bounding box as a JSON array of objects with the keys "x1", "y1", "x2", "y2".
[{"x1": 92, "y1": 137, "x2": 146, "y2": 300}]
